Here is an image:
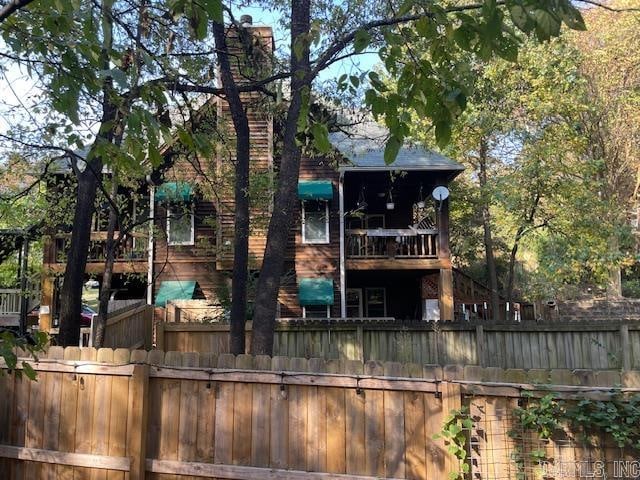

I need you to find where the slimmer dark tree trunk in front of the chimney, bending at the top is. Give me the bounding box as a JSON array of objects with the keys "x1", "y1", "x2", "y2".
[{"x1": 213, "y1": 23, "x2": 251, "y2": 355}]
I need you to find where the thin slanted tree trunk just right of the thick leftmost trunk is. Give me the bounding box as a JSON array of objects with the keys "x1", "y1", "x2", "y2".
[{"x1": 93, "y1": 175, "x2": 122, "y2": 348}]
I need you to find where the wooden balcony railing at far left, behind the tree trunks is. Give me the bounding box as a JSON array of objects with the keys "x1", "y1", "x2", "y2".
[{"x1": 54, "y1": 232, "x2": 148, "y2": 263}]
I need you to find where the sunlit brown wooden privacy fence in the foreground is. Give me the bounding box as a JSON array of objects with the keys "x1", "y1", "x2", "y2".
[{"x1": 0, "y1": 347, "x2": 640, "y2": 480}]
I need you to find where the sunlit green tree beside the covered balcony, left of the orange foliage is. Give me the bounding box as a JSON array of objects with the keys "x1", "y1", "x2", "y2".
[{"x1": 398, "y1": 39, "x2": 594, "y2": 296}]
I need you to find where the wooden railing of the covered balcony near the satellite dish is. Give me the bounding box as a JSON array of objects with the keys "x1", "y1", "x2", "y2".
[{"x1": 346, "y1": 228, "x2": 438, "y2": 258}]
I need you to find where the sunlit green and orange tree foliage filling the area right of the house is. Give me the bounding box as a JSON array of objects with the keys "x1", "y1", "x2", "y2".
[{"x1": 391, "y1": 1, "x2": 640, "y2": 297}]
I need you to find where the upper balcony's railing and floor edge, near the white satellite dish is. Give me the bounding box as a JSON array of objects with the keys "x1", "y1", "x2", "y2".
[{"x1": 345, "y1": 228, "x2": 448, "y2": 270}]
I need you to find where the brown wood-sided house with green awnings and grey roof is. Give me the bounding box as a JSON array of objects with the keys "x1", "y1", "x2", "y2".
[{"x1": 40, "y1": 19, "x2": 510, "y2": 330}]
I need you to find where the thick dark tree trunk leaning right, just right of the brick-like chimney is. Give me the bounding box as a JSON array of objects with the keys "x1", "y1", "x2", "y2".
[{"x1": 251, "y1": 0, "x2": 311, "y2": 355}]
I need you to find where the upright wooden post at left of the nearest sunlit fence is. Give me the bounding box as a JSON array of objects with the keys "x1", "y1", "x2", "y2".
[{"x1": 127, "y1": 365, "x2": 149, "y2": 480}]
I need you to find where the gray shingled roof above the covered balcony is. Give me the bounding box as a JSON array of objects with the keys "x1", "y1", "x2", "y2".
[{"x1": 329, "y1": 122, "x2": 464, "y2": 172}]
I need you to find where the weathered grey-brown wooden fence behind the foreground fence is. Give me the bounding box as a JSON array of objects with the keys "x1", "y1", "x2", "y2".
[{"x1": 157, "y1": 321, "x2": 640, "y2": 370}]
